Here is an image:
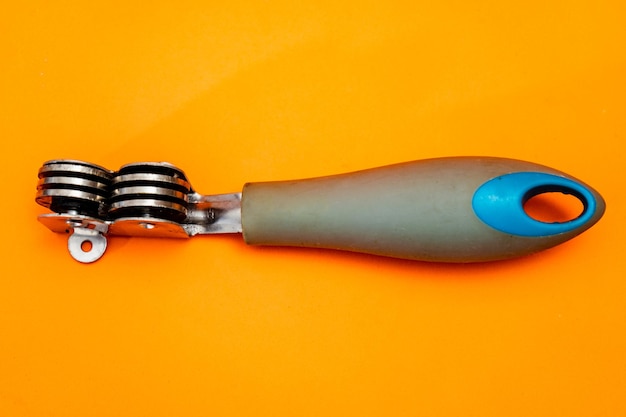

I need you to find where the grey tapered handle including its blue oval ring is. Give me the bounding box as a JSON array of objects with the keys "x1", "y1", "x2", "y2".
[{"x1": 242, "y1": 157, "x2": 604, "y2": 262}]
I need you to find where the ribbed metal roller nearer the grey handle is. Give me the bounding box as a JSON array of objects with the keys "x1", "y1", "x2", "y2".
[{"x1": 109, "y1": 162, "x2": 191, "y2": 222}]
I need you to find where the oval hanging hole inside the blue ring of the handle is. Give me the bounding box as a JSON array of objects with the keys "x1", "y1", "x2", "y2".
[{"x1": 523, "y1": 187, "x2": 587, "y2": 223}]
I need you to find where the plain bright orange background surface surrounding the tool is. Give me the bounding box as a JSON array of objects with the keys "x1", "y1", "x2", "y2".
[{"x1": 0, "y1": 0, "x2": 626, "y2": 417}]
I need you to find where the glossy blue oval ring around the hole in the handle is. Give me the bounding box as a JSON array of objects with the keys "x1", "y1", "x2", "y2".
[{"x1": 472, "y1": 172, "x2": 597, "y2": 237}]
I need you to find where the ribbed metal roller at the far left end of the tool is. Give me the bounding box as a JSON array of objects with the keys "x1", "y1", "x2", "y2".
[{"x1": 35, "y1": 159, "x2": 112, "y2": 218}]
